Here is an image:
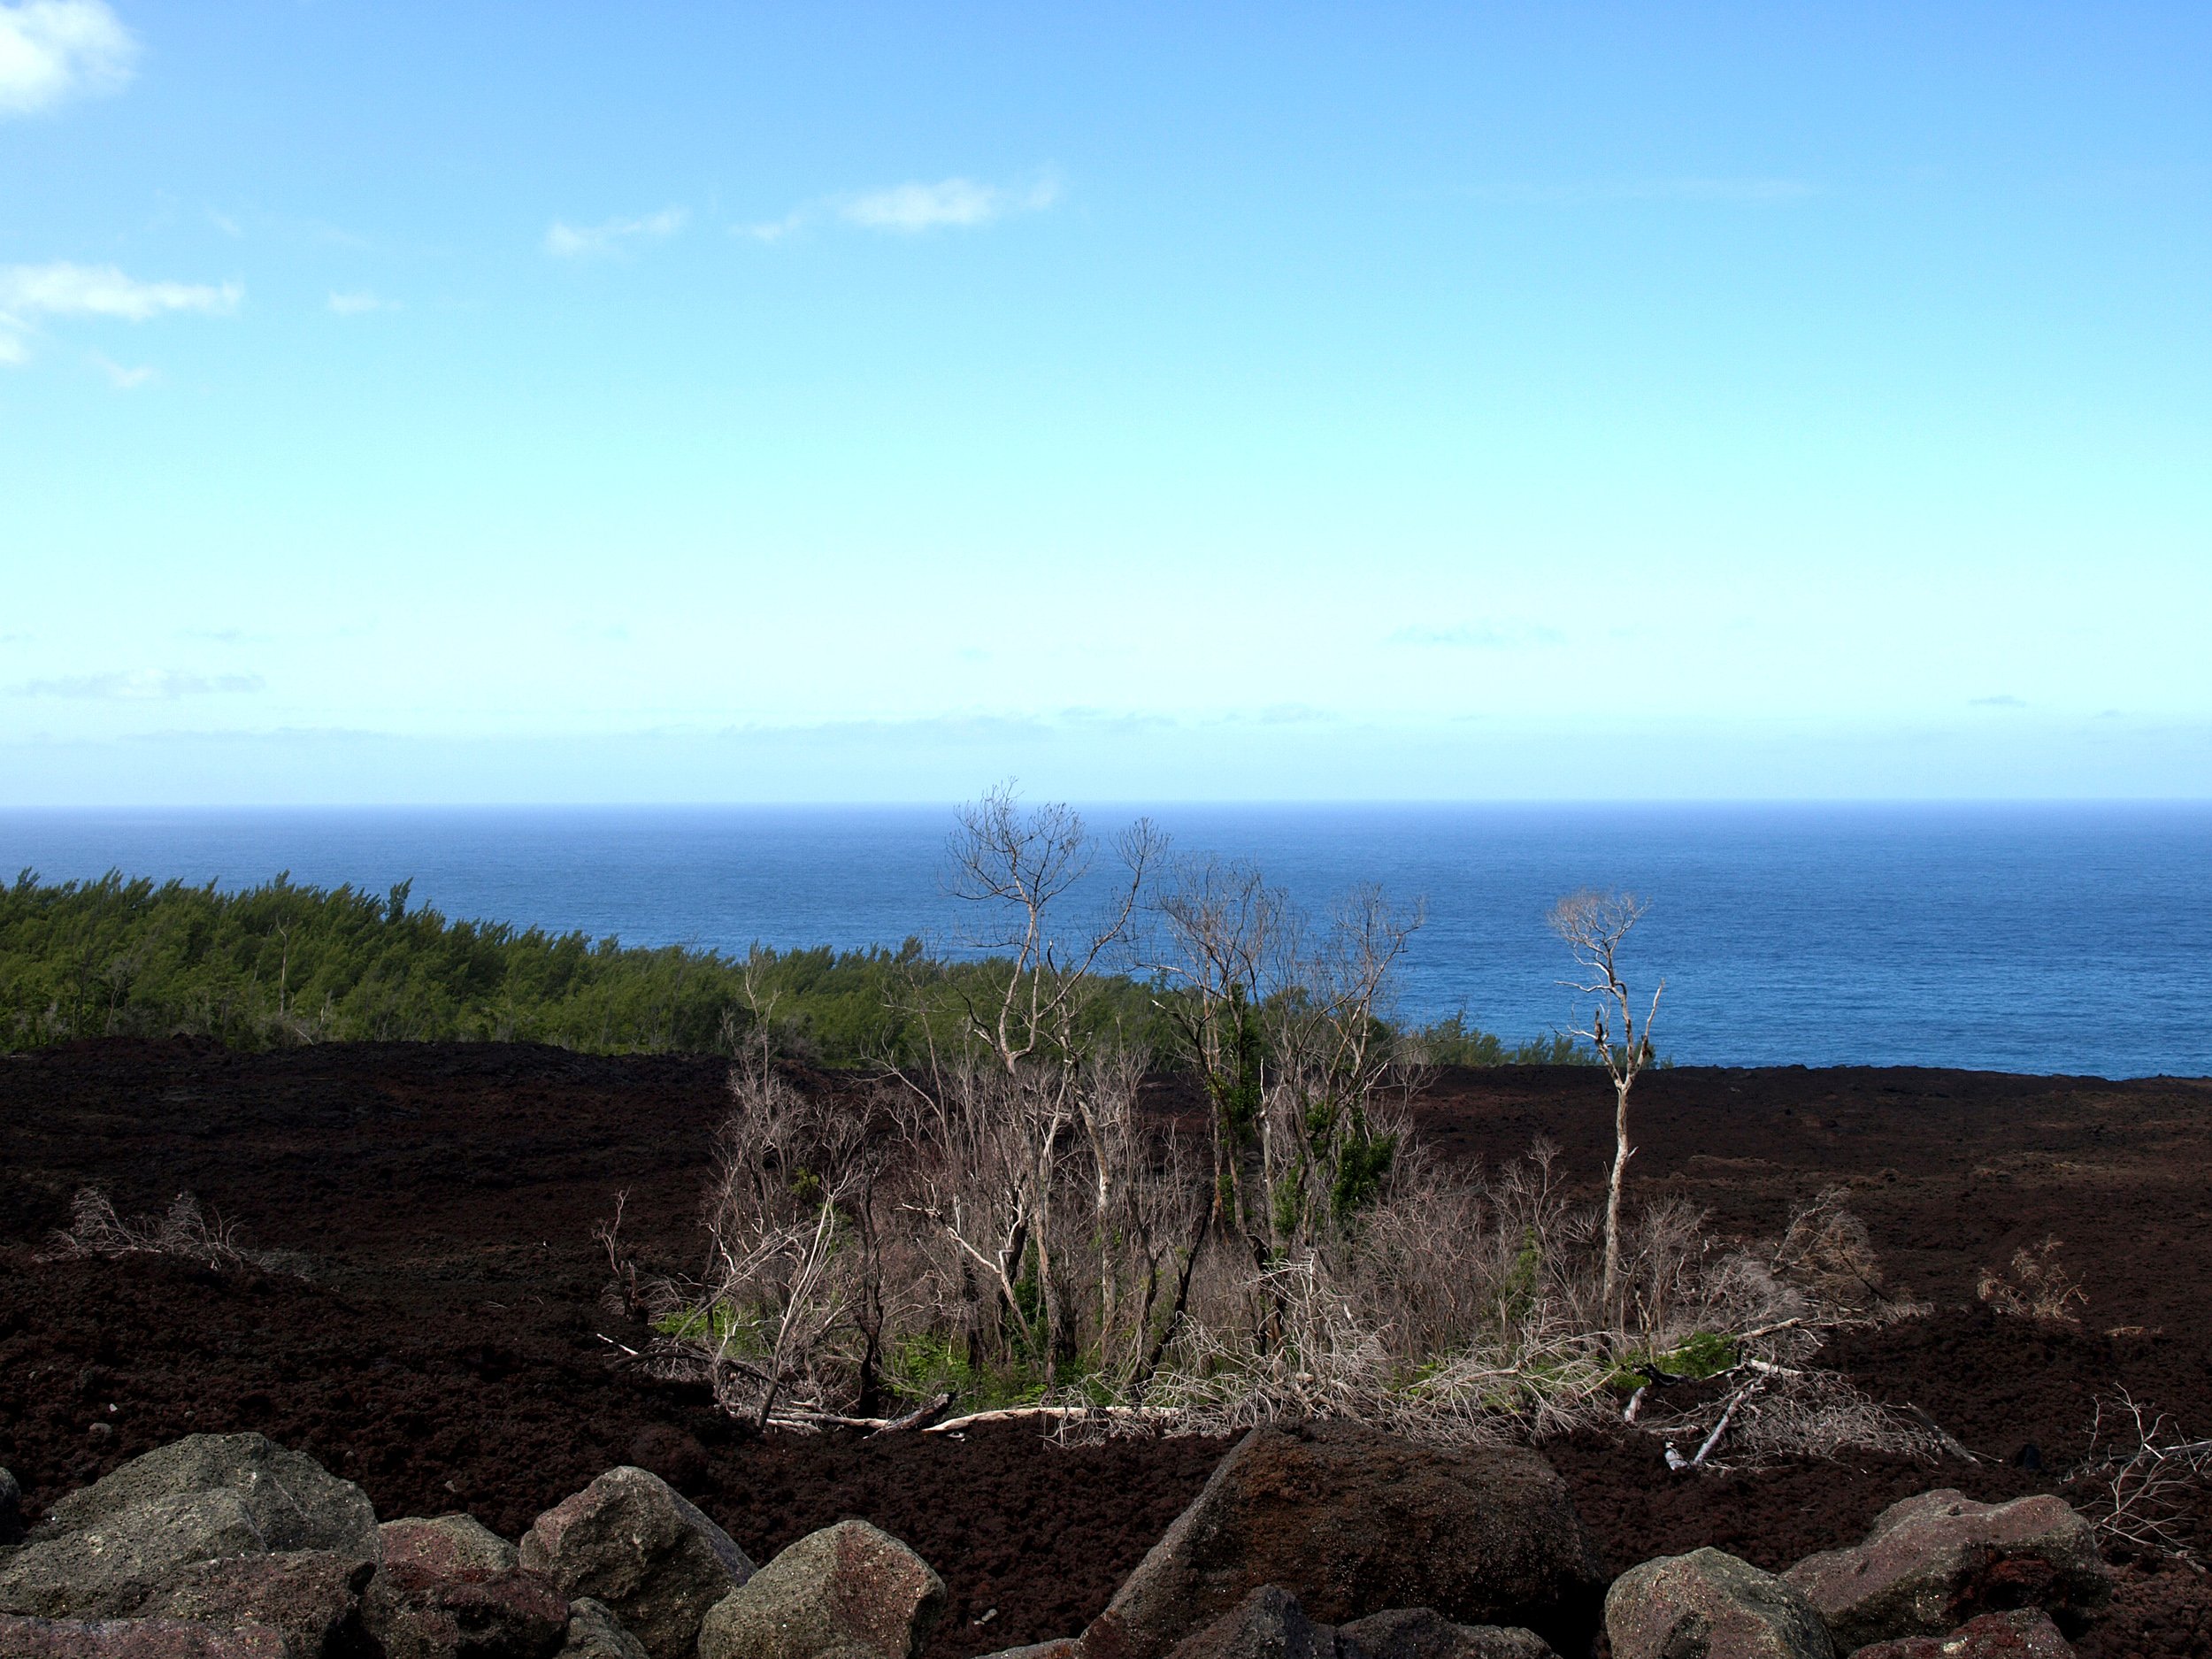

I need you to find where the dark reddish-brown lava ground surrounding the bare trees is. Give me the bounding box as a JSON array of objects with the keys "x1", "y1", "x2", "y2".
[{"x1": 0, "y1": 1042, "x2": 2212, "y2": 1659}]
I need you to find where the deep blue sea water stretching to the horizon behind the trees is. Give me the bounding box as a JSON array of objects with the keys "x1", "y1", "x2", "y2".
[{"x1": 0, "y1": 803, "x2": 2212, "y2": 1078}]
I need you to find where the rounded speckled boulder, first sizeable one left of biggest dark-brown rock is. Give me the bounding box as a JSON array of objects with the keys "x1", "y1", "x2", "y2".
[{"x1": 699, "y1": 1522, "x2": 945, "y2": 1659}]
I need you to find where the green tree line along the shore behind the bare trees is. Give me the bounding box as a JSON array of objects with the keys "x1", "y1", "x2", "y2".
[{"x1": 0, "y1": 870, "x2": 1575, "y2": 1066}]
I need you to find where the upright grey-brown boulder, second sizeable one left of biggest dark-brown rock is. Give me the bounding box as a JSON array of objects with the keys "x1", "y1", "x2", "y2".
[{"x1": 522, "y1": 1467, "x2": 752, "y2": 1659}]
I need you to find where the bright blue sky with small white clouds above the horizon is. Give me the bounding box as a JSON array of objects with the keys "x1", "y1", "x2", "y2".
[{"x1": 0, "y1": 0, "x2": 2212, "y2": 805}]
